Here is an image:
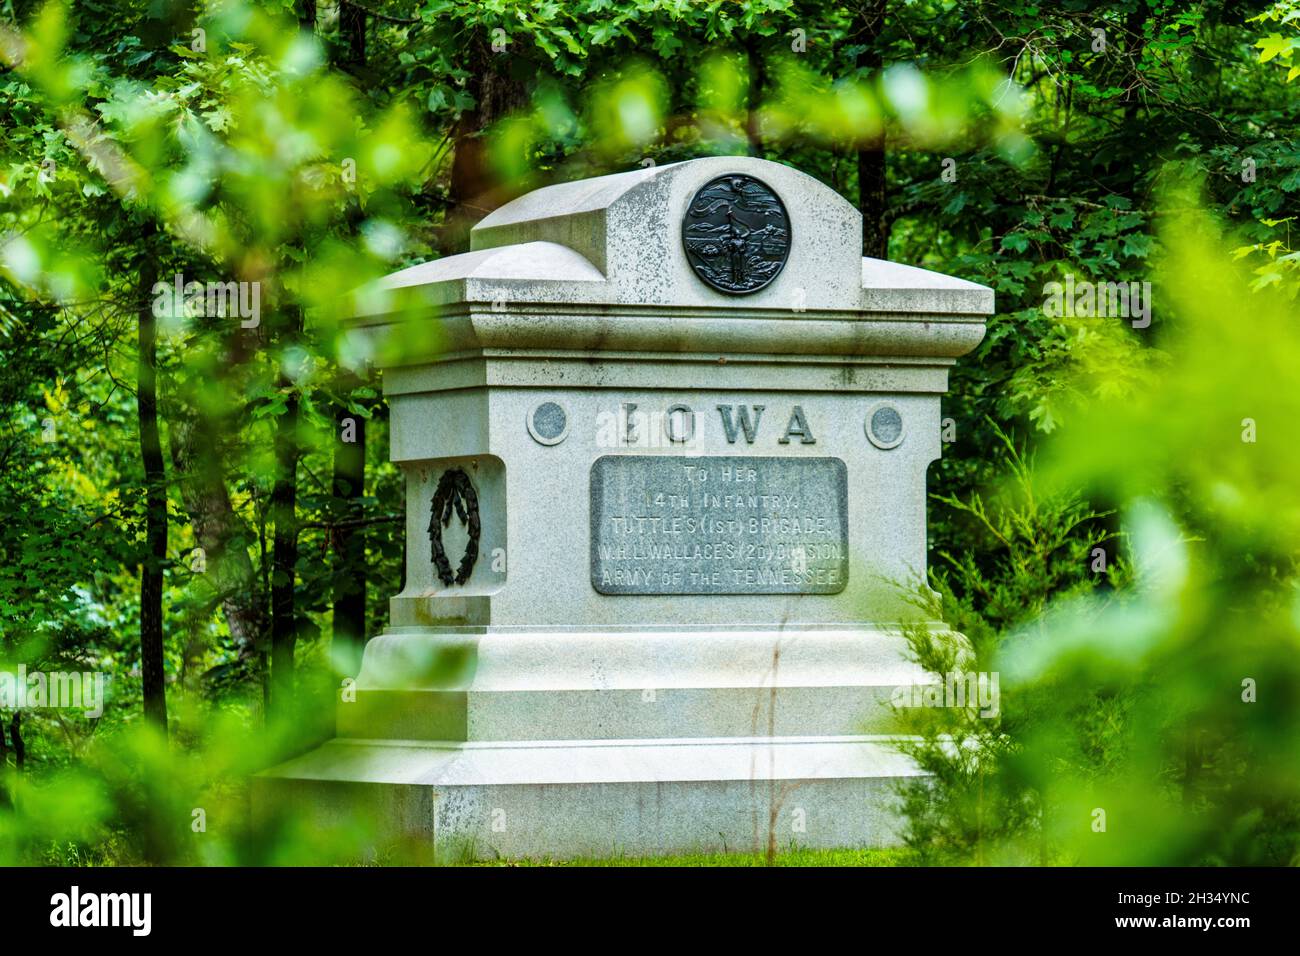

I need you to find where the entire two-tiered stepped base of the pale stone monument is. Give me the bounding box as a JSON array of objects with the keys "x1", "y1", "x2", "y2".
[{"x1": 254, "y1": 626, "x2": 946, "y2": 861}]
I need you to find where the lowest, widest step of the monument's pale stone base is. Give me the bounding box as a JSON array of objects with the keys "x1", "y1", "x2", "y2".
[{"x1": 254, "y1": 735, "x2": 920, "y2": 861}]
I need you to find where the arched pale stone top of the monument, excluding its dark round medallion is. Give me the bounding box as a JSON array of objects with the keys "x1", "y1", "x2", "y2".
[{"x1": 358, "y1": 156, "x2": 993, "y2": 335}]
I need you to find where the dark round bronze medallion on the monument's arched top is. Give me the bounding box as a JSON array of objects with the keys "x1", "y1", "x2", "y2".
[{"x1": 681, "y1": 173, "x2": 790, "y2": 295}]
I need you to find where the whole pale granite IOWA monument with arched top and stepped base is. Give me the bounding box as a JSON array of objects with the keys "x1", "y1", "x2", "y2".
[{"x1": 257, "y1": 156, "x2": 993, "y2": 857}]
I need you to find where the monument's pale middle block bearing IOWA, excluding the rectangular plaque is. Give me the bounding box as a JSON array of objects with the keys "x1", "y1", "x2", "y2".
[{"x1": 389, "y1": 387, "x2": 940, "y2": 627}]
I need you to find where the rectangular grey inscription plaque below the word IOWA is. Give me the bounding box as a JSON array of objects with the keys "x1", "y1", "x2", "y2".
[{"x1": 592, "y1": 455, "x2": 849, "y2": 594}]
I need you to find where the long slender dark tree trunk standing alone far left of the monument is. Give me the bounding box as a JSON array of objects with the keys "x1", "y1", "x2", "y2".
[{"x1": 135, "y1": 258, "x2": 168, "y2": 736}]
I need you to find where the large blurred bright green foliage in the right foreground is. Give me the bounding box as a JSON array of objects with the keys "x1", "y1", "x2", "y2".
[{"x1": 902, "y1": 195, "x2": 1300, "y2": 865}]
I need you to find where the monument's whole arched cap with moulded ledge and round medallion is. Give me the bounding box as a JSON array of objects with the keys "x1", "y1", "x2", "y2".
[{"x1": 358, "y1": 156, "x2": 993, "y2": 367}]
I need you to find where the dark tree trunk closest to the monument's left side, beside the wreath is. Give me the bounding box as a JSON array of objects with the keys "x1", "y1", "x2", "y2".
[{"x1": 333, "y1": 392, "x2": 365, "y2": 674}]
